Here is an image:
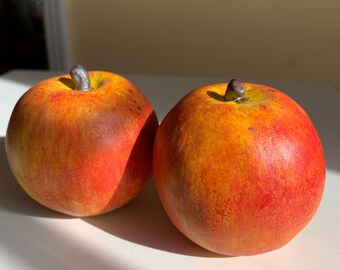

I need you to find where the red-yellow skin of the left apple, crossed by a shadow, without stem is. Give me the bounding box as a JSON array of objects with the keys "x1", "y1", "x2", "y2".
[{"x1": 6, "y1": 71, "x2": 158, "y2": 217}]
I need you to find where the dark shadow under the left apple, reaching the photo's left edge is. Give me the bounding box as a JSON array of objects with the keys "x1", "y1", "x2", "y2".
[{"x1": 0, "y1": 137, "x2": 70, "y2": 218}]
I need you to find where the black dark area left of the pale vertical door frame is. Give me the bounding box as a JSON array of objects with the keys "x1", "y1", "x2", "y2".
[{"x1": 0, "y1": 0, "x2": 48, "y2": 74}]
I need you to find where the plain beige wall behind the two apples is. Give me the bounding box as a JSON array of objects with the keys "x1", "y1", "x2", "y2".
[{"x1": 68, "y1": 0, "x2": 340, "y2": 89}]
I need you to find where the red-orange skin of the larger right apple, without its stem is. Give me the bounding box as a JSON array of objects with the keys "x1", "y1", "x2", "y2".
[{"x1": 153, "y1": 83, "x2": 325, "y2": 256}]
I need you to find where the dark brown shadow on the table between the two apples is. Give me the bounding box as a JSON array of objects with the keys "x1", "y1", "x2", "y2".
[{"x1": 83, "y1": 179, "x2": 226, "y2": 258}]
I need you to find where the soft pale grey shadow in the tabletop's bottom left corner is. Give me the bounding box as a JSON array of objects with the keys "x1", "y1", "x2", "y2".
[{"x1": 0, "y1": 211, "x2": 125, "y2": 270}]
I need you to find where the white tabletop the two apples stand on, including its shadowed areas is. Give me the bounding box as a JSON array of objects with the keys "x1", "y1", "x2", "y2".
[{"x1": 0, "y1": 70, "x2": 340, "y2": 270}]
